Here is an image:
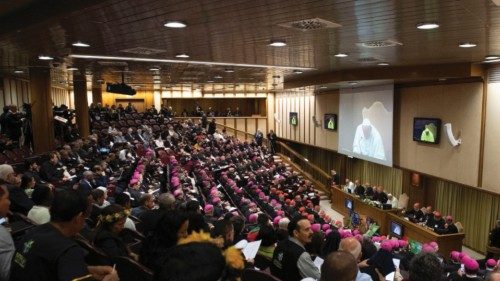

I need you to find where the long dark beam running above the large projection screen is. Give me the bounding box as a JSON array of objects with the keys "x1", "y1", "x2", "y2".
[{"x1": 284, "y1": 63, "x2": 483, "y2": 89}]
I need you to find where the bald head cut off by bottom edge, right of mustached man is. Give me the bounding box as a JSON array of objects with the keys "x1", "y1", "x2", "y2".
[{"x1": 320, "y1": 251, "x2": 358, "y2": 281}]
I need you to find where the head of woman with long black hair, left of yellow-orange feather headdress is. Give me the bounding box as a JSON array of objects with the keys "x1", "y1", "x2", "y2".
[{"x1": 140, "y1": 211, "x2": 189, "y2": 273}]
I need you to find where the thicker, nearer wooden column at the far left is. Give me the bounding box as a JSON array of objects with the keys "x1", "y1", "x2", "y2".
[{"x1": 30, "y1": 66, "x2": 55, "y2": 154}]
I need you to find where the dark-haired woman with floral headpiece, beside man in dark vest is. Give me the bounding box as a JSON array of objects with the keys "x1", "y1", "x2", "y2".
[{"x1": 93, "y1": 204, "x2": 138, "y2": 260}]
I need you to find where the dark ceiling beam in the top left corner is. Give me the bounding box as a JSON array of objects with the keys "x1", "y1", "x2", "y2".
[{"x1": 0, "y1": 0, "x2": 104, "y2": 35}]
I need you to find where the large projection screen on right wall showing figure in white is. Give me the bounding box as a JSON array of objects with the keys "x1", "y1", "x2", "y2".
[{"x1": 338, "y1": 84, "x2": 394, "y2": 166}]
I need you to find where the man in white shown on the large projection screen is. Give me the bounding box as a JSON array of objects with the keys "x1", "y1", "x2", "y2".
[{"x1": 352, "y1": 118, "x2": 386, "y2": 160}]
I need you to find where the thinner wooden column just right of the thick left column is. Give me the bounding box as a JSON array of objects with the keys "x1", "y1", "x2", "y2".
[{"x1": 73, "y1": 75, "x2": 90, "y2": 138}]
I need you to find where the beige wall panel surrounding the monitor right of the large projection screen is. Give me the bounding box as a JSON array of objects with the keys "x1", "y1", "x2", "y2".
[{"x1": 395, "y1": 82, "x2": 483, "y2": 186}]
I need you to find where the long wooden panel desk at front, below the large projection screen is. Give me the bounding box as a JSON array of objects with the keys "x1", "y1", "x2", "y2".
[{"x1": 331, "y1": 188, "x2": 465, "y2": 258}]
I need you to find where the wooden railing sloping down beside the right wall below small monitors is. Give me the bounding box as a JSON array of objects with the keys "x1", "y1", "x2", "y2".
[{"x1": 276, "y1": 141, "x2": 332, "y2": 193}]
